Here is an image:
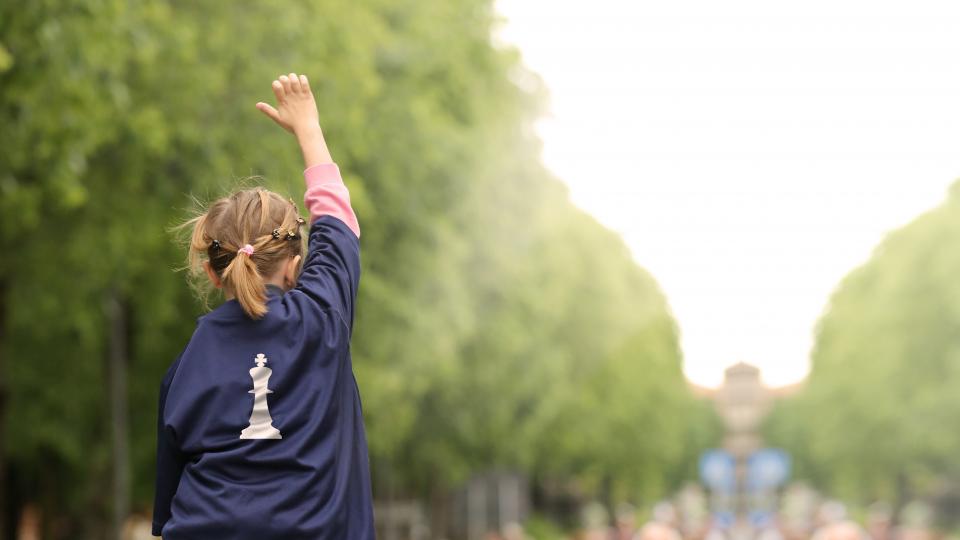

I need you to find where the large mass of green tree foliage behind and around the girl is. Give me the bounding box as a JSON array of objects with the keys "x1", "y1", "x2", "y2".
[{"x1": 0, "y1": 0, "x2": 709, "y2": 537}]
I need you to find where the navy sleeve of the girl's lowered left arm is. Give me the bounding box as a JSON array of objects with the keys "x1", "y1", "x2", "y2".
[{"x1": 153, "y1": 358, "x2": 186, "y2": 536}]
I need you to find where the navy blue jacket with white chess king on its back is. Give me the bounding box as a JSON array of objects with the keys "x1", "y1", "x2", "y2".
[{"x1": 153, "y1": 212, "x2": 374, "y2": 540}]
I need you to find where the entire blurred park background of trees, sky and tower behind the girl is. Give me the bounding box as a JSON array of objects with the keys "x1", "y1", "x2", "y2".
[{"x1": 0, "y1": 0, "x2": 960, "y2": 540}]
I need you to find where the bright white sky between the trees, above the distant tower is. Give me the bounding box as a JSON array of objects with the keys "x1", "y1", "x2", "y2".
[{"x1": 497, "y1": 0, "x2": 960, "y2": 386}]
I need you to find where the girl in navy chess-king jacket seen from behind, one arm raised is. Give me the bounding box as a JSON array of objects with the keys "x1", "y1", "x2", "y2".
[{"x1": 153, "y1": 73, "x2": 374, "y2": 540}]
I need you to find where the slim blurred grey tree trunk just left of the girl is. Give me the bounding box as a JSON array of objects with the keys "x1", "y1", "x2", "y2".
[{"x1": 107, "y1": 288, "x2": 130, "y2": 540}]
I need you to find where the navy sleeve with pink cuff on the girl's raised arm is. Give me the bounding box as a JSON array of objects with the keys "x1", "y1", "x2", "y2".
[{"x1": 297, "y1": 163, "x2": 360, "y2": 325}]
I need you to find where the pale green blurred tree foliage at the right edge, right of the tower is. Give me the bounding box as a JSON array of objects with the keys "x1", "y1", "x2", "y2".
[{"x1": 769, "y1": 184, "x2": 960, "y2": 516}]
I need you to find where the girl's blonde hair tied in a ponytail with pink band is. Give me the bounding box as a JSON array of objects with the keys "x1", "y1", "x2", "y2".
[{"x1": 177, "y1": 188, "x2": 304, "y2": 319}]
